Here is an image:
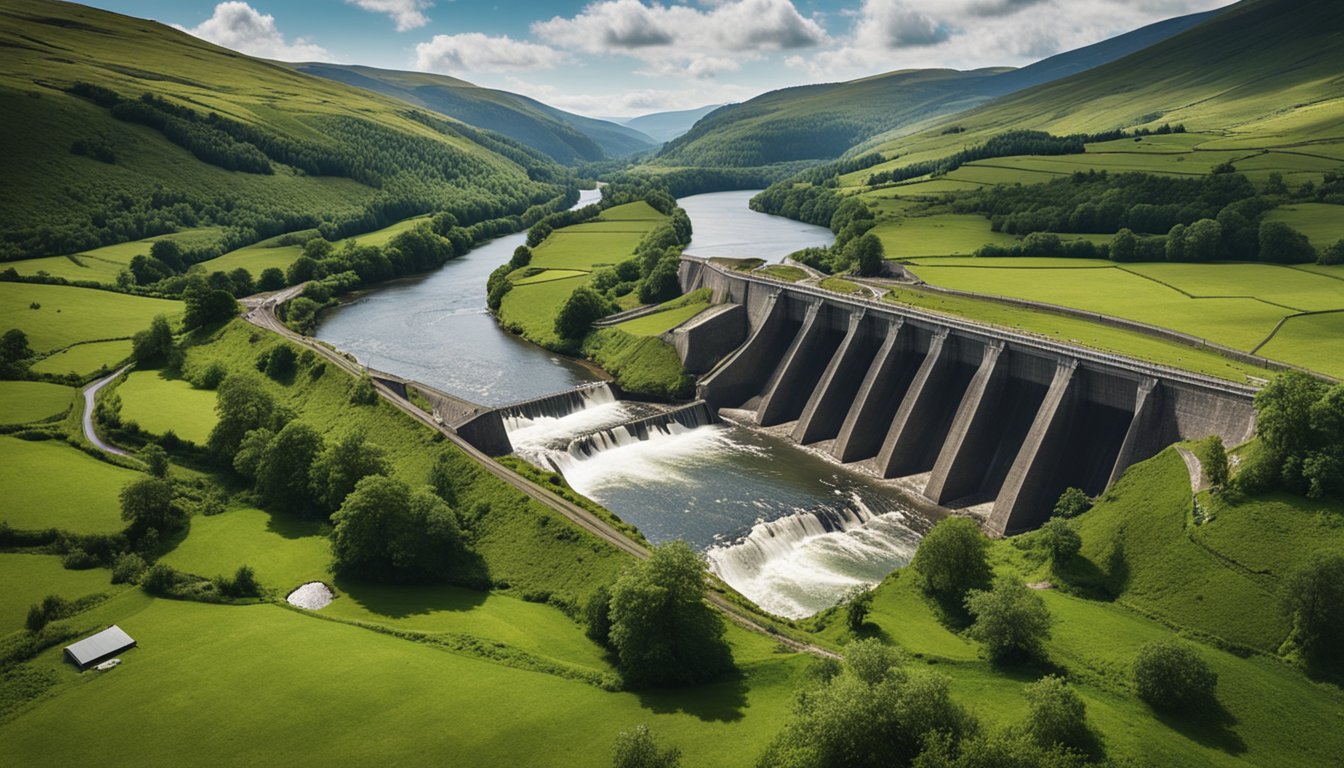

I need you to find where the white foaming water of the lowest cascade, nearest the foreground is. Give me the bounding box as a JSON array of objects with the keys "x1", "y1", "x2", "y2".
[{"x1": 706, "y1": 494, "x2": 919, "y2": 619}]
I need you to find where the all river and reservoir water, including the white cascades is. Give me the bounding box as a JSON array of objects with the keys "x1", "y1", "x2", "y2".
[{"x1": 316, "y1": 191, "x2": 929, "y2": 617}]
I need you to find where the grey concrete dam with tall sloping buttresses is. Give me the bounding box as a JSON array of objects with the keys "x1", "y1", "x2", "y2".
[{"x1": 677, "y1": 257, "x2": 1255, "y2": 535}]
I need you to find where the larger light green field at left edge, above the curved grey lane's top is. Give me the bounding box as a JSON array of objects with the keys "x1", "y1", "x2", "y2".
[{"x1": 0, "y1": 282, "x2": 183, "y2": 354}]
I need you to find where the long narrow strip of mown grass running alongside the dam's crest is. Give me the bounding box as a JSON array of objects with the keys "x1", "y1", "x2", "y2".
[{"x1": 886, "y1": 288, "x2": 1266, "y2": 382}]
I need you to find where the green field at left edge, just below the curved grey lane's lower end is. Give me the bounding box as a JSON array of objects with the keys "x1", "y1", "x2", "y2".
[{"x1": 0, "y1": 436, "x2": 142, "y2": 534}]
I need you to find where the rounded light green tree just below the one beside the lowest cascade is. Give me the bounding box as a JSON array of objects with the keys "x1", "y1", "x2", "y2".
[{"x1": 966, "y1": 576, "x2": 1050, "y2": 662}]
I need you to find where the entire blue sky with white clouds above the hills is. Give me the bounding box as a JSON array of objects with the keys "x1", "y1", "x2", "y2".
[{"x1": 86, "y1": 0, "x2": 1228, "y2": 117}]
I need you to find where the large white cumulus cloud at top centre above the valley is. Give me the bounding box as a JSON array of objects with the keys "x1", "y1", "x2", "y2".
[{"x1": 532, "y1": 0, "x2": 828, "y2": 77}]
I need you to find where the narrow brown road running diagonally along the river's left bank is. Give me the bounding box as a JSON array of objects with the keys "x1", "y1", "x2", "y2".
[{"x1": 243, "y1": 295, "x2": 839, "y2": 658}]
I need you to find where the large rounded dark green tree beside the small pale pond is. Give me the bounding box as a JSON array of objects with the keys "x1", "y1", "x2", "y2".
[{"x1": 332, "y1": 475, "x2": 461, "y2": 581}]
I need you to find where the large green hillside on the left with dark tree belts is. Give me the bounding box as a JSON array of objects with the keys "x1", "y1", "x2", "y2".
[{"x1": 0, "y1": 0, "x2": 562, "y2": 260}]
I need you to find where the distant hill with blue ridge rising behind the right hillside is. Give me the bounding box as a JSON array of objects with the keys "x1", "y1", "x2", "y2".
[{"x1": 657, "y1": 8, "x2": 1214, "y2": 167}]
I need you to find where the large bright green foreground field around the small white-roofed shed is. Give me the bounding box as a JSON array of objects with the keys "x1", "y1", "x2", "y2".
[{"x1": 0, "y1": 592, "x2": 806, "y2": 767}]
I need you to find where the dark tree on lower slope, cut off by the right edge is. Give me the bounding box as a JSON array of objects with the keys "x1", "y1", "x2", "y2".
[{"x1": 1282, "y1": 551, "x2": 1344, "y2": 663}]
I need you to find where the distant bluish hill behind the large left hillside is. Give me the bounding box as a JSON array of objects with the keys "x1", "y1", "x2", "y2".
[{"x1": 290, "y1": 63, "x2": 657, "y2": 163}]
